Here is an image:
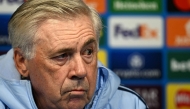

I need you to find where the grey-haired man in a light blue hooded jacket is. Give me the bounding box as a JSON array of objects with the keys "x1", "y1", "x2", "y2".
[{"x1": 0, "y1": 0, "x2": 147, "y2": 109}]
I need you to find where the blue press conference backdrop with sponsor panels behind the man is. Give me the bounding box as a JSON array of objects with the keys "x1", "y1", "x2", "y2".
[{"x1": 0, "y1": 0, "x2": 190, "y2": 109}]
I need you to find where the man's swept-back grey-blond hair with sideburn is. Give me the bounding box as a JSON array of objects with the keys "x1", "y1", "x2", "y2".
[{"x1": 8, "y1": 0, "x2": 102, "y2": 59}]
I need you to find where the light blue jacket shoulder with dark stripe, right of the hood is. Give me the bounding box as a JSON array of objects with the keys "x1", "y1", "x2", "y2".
[{"x1": 106, "y1": 86, "x2": 149, "y2": 109}]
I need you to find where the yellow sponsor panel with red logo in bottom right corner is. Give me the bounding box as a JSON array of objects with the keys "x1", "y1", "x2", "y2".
[{"x1": 166, "y1": 83, "x2": 190, "y2": 109}]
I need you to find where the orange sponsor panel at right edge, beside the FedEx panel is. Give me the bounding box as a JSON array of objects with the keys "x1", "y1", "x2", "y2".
[{"x1": 167, "y1": 17, "x2": 190, "y2": 47}]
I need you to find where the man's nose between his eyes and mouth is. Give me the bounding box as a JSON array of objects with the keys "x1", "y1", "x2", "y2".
[{"x1": 69, "y1": 55, "x2": 87, "y2": 79}]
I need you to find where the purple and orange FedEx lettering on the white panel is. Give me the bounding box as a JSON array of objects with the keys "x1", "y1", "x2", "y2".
[{"x1": 115, "y1": 24, "x2": 158, "y2": 38}]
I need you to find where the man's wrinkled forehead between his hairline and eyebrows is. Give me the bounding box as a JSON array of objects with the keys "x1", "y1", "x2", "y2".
[{"x1": 36, "y1": 16, "x2": 95, "y2": 41}]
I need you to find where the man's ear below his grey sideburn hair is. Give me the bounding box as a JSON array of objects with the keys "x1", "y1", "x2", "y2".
[{"x1": 14, "y1": 48, "x2": 29, "y2": 78}]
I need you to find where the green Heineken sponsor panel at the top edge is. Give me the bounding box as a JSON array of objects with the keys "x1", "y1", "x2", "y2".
[{"x1": 111, "y1": 0, "x2": 161, "y2": 12}]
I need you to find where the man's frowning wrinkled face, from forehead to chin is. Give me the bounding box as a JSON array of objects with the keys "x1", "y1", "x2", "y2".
[{"x1": 27, "y1": 16, "x2": 97, "y2": 109}]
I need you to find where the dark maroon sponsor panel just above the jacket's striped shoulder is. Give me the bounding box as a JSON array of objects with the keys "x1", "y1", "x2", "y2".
[{"x1": 126, "y1": 85, "x2": 162, "y2": 109}]
